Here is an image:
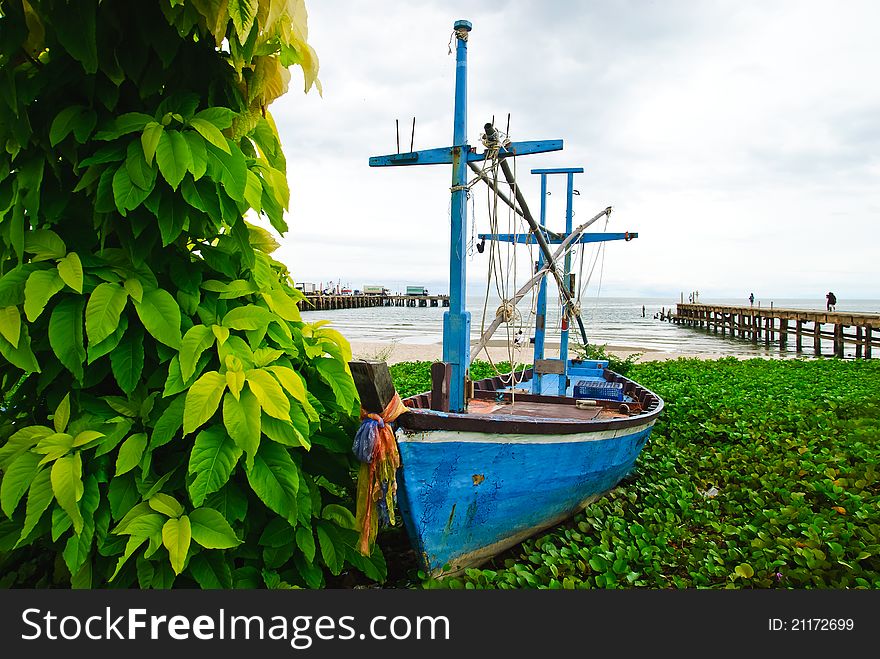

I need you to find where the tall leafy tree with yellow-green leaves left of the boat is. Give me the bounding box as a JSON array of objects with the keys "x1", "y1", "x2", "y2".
[{"x1": 0, "y1": 0, "x2": 385, "y2": 588}]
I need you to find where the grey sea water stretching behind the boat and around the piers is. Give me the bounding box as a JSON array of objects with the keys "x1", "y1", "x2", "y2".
[{"x1": 302, "y1": 296, "x2": 880, "y2": 357}]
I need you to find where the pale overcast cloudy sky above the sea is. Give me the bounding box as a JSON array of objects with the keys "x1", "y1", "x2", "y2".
[{"x1": 262, "y1": 0, "x2": 880, "y2": 303}]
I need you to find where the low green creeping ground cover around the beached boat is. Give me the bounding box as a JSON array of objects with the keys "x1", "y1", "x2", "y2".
[{"x1": 389, "y1": 358, "x2": 880, "y2": 588}]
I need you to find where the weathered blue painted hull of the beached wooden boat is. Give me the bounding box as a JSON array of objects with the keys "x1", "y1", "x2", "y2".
[{"x1": 397, "y1": 416, "x2": 656, "y2": 576}]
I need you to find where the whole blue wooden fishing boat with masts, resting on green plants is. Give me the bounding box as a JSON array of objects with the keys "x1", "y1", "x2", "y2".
[{"x1": 350, "y1": 20, "x2": 663, "y2": 575}]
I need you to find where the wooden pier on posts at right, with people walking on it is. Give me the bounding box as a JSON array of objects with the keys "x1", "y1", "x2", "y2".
[{"x1": 668, "y1": 303, "x2": 880, "y2": 359}]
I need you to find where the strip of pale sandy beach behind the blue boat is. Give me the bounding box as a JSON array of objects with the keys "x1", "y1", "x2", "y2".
[{"x1": 351, "y1": 341, "x2": 726, "y2": 364}]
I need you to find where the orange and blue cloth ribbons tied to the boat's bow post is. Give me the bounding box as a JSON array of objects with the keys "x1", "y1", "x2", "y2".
[{"x1": 351, "y1": 393, "x2": 409, "y2": 556}]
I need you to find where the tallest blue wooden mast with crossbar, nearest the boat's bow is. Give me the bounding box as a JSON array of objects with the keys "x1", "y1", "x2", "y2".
[{"x1": 370, "y1": 20, "x2": 562, "y2": 412}]
